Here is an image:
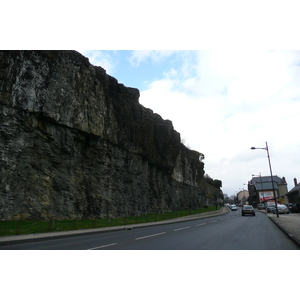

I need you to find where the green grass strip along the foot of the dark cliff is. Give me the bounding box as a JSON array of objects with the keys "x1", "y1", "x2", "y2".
[{"x1": 0, "y1": 207, "x2": 217, "y2": 236}]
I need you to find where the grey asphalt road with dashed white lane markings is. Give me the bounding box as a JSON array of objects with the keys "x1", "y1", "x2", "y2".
[{"x1": 0, "y1": 208, "x2": 299, "y2": 250}]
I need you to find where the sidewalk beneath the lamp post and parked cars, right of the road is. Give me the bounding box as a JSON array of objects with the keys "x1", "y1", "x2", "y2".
[{"x1": 259, "y1": 210, "x2": 300, "y2": 248}]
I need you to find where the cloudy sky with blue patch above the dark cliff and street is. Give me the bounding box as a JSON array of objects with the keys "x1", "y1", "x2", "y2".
[{"x1": 79, "y1": 50, "x2": 300, "y2": 196}]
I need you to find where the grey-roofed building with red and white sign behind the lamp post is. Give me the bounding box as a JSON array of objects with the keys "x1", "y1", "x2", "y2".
[{"x1": 248, "y1": 175, "x2": 288, "y2": 207}]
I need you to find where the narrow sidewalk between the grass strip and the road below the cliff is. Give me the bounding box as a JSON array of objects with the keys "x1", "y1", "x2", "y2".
[{"x1": 0, "y1": 207, "x2": 229, "y2": 246}]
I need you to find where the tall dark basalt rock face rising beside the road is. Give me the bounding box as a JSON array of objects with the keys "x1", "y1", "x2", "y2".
[{"x1": 0, "y1": 51, "x2": 220, "y2": 219}]
